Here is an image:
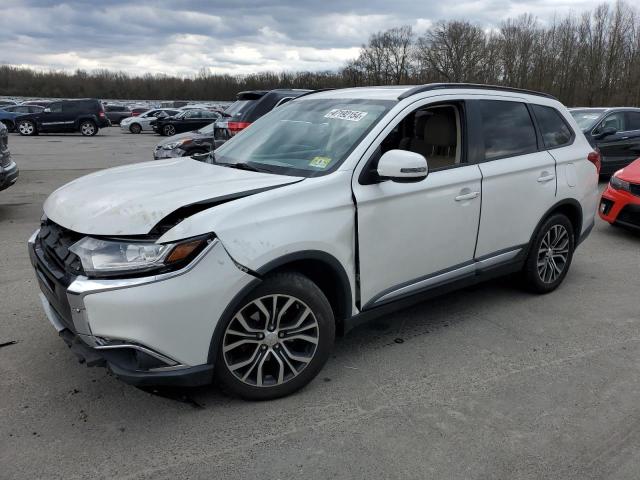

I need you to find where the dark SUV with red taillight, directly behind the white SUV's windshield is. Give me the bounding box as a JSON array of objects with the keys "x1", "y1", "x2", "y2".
[{"x1": 214, "y1": 88, "x2": 311, "y2": 144}]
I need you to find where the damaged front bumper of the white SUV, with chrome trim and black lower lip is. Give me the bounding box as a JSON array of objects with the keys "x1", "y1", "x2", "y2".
[{"x1": 28, "y1": 227, "x2": 252, "y2": 386}]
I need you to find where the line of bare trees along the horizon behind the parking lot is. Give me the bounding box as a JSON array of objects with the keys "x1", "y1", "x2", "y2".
[{"x1": 0, "y1": 1, "x2": 640, "y2": 106}]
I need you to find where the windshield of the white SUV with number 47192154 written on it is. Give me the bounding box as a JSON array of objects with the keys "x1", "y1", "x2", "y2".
[{"x1": 215, "y1": 99, "x2": 395, "y2": 177}]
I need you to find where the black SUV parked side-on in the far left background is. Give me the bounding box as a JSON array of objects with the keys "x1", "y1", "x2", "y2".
[{"x1": 17, "y1": 99, "x2": 111, "y2": 136}]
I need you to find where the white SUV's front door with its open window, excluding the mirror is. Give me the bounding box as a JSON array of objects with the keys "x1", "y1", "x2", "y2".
[{"x1": 352, "y1": 103, "x2": 481, "y2": 309}]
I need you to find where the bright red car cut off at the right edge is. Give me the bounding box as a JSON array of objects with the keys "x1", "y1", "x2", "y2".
[{"x1": 599, "y1": 158, "x2": 640, "y2": 230}]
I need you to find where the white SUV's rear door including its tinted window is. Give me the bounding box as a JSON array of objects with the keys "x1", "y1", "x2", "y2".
[{"x1": 470, "y1": 99, "x2": 556, "y2": 259}]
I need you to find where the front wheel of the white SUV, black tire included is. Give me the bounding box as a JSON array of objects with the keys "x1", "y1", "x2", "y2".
[{"x1": 216, "y1": 272, "x2": 335, "y2": 400}]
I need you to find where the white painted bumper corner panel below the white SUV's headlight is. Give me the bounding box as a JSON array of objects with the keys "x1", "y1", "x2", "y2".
[{"x1": 84, "y1": 243, "x2": 255, "y2": 366}]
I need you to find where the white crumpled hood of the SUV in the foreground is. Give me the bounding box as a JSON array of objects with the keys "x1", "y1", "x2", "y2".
[{"x1": 44, "y1": 158, "x2": 301, "y2": 236}]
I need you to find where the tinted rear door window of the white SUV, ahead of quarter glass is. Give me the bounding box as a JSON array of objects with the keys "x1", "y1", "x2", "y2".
[{"x1": 479, "y1": 100, "x2": 538, "y2": 160}]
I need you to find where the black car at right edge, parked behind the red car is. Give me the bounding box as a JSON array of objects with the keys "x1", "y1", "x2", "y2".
[{"x1": 569, "y1": 107, "x2": 640, "y2": 175}]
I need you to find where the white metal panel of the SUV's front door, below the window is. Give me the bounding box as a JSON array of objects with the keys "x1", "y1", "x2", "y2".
[{"x1": 353, "y1": 165, "x2": 481, "y2": 305}]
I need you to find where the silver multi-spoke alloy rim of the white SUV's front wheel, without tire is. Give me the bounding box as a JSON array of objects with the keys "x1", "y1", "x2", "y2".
[{"x1": 222, "y1": 294, "x2": 320, "y2": 387}]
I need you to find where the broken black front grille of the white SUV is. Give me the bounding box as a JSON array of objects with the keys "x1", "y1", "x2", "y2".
[{"x1": 38, "y1": 220, "x2": 84, "y2": 275}]
